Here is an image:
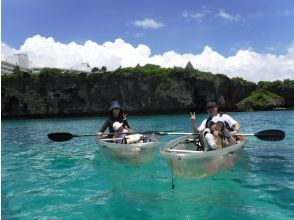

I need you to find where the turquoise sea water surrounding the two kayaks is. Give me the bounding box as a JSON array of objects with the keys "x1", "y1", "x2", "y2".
[{"x1": 1, "y1": 111, "x2": 294, "y2": 220}]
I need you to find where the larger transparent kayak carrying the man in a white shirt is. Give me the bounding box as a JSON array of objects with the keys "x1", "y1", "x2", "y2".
[{"x1": 160, "y1": 136, "x2": 247, "y2": 179}]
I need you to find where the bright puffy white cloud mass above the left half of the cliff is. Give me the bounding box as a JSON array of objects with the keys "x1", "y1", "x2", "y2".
[{"x1": 13, "y1": 35, "x2": 151, "y2": 70}]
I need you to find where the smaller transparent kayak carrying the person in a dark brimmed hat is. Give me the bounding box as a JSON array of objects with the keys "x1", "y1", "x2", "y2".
[{"x1": 97, "y1": 135, "x2": 160, "y2": 166}]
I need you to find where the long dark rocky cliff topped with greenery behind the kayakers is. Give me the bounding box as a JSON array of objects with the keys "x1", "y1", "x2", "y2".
[{"x1": 1, "y1": 66, "x2": 290, "y2": 118}]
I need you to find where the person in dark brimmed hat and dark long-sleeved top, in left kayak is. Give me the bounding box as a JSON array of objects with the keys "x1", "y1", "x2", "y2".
[{"x1": 97, "y1": 101, "x2": 132, "y2": 137}]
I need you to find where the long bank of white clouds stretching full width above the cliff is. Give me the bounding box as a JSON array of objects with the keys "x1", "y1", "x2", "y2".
[{"x1": 1, "y1": 35, "x2": 294, "y2": 82}]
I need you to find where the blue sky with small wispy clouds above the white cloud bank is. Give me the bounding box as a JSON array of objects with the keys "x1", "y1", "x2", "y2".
[{"x1": 1, "y1": 0, "x2": 294, "y2": 79}]
